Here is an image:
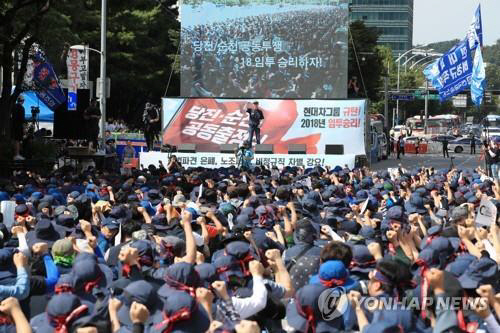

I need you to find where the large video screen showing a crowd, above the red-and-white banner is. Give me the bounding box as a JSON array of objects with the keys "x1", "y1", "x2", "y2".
[{"x1": 181, "y1": 6, "x2": 347, "y2": 98}]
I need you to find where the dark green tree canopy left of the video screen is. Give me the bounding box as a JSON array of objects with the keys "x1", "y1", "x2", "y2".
[{"x1": 0, "y1": 0, "x2": 180, "y2": 135}]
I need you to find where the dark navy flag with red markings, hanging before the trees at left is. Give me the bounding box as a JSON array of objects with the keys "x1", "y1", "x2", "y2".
[{"x1": 33, "y1": 52, "x2": 66, "y2": 111}]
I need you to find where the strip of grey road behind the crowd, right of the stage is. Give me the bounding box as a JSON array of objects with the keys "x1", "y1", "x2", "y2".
[{"x1": 372, "y1": 153, "x2": 484, "y2": 171}]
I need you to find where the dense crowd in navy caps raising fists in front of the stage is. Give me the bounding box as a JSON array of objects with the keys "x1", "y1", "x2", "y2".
[{"x1": 0, "y1": 163, "x2": 500, "y2": 333}]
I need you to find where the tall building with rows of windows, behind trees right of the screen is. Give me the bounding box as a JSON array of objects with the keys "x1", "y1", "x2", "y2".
[{"x1": 349, "y1": 0, "x2": 413, "y2": 56}]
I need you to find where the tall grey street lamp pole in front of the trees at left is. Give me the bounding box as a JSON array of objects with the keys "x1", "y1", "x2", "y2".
[{"x1": 70, "y1": 0, "x2": 108, "y2": 147}]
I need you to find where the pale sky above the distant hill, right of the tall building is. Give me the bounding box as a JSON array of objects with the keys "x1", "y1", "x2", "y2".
[{"x1": 413, "y1": 0, "x2": 500, "y2": 45}]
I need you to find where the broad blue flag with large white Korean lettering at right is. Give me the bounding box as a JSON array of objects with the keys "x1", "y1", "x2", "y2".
[{"x1": 424, "y1": 40, "x2": 472, "y2": 101}]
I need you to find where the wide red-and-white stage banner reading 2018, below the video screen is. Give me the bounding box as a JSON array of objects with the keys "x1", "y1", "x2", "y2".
[{"x1": 162, "y1": 98, "x2": 366, "y2": 155}]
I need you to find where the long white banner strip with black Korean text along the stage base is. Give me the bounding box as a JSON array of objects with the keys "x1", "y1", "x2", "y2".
[{"x1": 139, "y1": 151, "x2": 357, "y2": 168}]
